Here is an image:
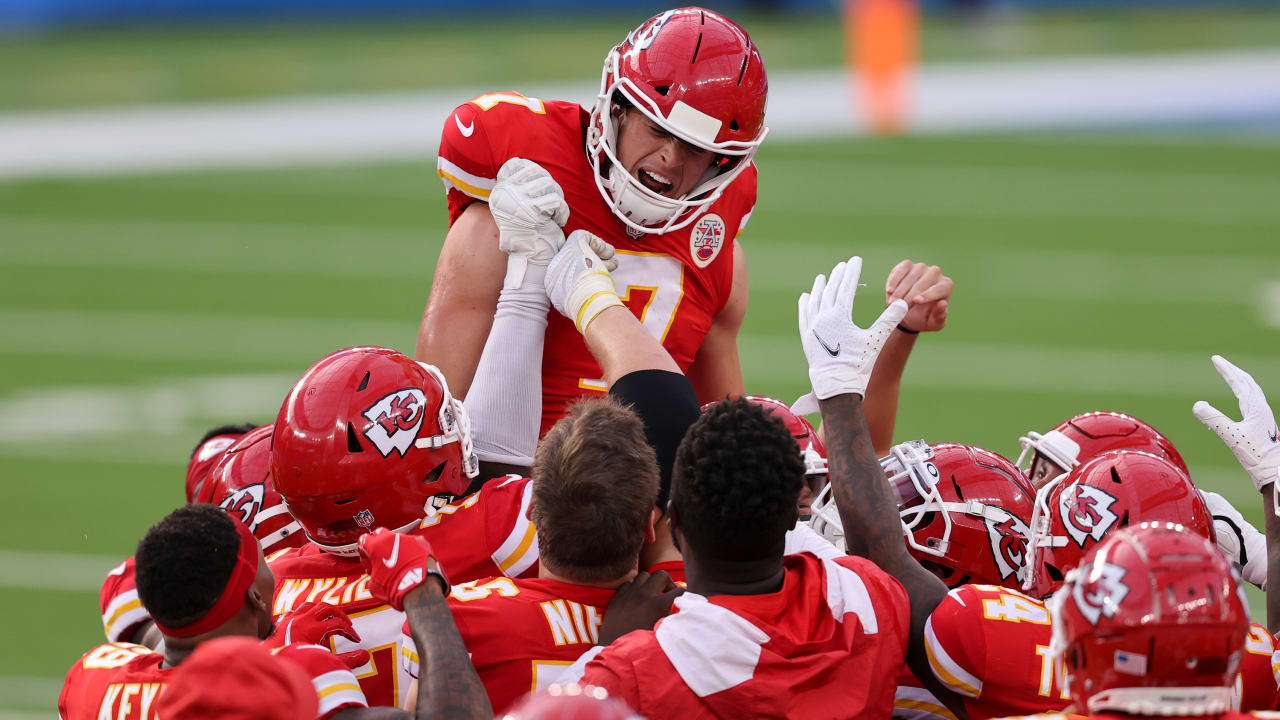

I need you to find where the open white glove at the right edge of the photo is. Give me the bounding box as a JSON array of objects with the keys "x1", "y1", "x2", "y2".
[{"x1": 1192, "y1": 355, "x2": 1280, "y2": 489}]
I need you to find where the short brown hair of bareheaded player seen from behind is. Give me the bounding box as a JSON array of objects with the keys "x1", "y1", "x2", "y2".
[{"x1": 529, "y1": 397, "x2": 658, "y2": 582}]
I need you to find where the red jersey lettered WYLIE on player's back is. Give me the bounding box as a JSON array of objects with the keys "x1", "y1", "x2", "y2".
[{"x1": 268, "y1": 543, "x2": 411, "y2": 707}]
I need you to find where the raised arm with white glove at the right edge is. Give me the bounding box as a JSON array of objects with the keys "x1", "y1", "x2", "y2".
[{"x1": 1192, "y1": 355, "x2": 1280, "y2": 634}]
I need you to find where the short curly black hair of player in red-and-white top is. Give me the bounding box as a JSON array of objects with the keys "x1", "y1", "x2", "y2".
[{"x1": 671, "y1": 397, "x2": 804, "y2": 561}]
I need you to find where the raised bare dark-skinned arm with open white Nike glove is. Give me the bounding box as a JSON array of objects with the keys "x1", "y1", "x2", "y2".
[{"x1": 800, "y1": 258, "x2": 947, "y2": 696}]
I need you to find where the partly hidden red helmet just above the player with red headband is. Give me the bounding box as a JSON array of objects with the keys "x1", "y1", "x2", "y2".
[{"x1": 196, "y1": 425, "x2": 307, "y2": 555}]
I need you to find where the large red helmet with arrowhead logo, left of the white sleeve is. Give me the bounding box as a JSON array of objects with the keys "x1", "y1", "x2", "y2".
[{"x1": 271, "y1": 347, "x2": 479, "y2": 555}]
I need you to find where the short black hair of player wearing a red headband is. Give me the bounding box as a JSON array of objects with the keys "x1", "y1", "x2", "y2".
[{"x1": 134, "y1": 502, "x2": 241, "y2": 626}]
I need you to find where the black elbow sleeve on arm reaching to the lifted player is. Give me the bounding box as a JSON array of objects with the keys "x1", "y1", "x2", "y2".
[{"x1": 609, "y1": 370, "x2": 700, "y2": 512}]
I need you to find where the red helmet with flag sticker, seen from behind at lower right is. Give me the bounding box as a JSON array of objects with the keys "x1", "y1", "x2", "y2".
[{"x1": 1050, "y1": 523, "x2": 1249, "y2": 715}]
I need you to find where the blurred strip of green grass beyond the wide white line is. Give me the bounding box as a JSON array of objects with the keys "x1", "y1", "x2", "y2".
[{"x1": 0, "y1": 8, "x2": 1280, "y2": 110}]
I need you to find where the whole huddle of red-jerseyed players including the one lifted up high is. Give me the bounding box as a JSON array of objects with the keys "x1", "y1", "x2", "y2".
[{"x1": 59, "y1": 8, "x2": 1280, "y2": 720}]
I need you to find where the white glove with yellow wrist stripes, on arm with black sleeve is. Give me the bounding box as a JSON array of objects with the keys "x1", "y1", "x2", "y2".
[{"x1": 547, "y1": 231, "x2": 622, "y2": 333}]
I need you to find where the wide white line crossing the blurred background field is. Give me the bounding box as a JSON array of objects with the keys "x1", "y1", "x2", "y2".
[{"x1": 0, "y1": 51, "x2": 1280, "y2": 178}]
